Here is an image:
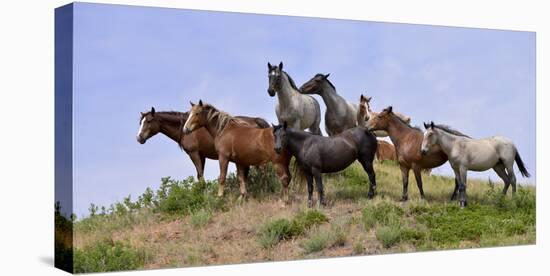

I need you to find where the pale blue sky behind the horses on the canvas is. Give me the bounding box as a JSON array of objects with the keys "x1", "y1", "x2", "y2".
[{"x1": 73, "y1": 3, "x2": 536, "y2": 216}]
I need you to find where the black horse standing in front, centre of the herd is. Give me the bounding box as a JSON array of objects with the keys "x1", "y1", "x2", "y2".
[{"x1": 273, "y1": 122, "x2": 378, "y2": 207}]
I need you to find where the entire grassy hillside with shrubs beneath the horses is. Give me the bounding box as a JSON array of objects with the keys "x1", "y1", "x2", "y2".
[{"x1": 74, "y1": 163, "x2": 535, "y2": 272}]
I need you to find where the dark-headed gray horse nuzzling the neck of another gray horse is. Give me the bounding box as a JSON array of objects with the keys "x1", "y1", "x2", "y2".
[{"x1": 300, "y1": 74, "x2": 357, "y2": 136}]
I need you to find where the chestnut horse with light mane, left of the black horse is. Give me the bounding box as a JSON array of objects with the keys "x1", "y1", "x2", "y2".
[{"x1": 183, "y1": 100, "x2": 291, "y2": 203}]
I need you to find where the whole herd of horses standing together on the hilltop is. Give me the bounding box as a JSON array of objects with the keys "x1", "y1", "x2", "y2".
[{"x1": 137, "y1": 62, "x2": 529, "y2": 207}]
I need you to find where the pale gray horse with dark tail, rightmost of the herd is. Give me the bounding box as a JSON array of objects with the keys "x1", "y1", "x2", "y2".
[{"x1": 422, "y1": 122, "x2": 530, "y2": 207}]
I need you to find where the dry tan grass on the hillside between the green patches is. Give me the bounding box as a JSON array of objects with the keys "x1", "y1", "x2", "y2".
[{"x1": 75, "y1": 163, "x2": 535, "y2": 268}]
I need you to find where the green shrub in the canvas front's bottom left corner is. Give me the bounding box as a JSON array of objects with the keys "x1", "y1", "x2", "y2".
[{"x1": 74, "y1": 240, "x2": 146, "y2": 273}]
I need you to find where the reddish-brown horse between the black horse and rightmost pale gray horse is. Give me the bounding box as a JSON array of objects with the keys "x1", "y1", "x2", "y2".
[{"x1": 366, "y1": 106, "x2": 458, "y2": 201}]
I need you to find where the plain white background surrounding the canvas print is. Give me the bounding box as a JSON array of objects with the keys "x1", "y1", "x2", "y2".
[{"x1": 0, "y1": 0, "x2": 550, "y2": 275}]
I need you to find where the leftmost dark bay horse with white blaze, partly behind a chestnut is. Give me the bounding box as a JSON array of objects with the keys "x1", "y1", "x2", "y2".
[{"x1": 136, "y1": 107, "x2": 269, "y2": 179}]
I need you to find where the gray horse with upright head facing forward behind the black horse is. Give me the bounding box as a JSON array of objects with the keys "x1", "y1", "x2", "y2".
[{"x1": 267, "y1": 62, "x2": 321, "y2": 135}]
